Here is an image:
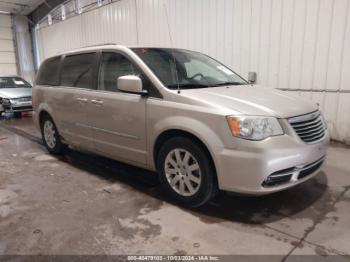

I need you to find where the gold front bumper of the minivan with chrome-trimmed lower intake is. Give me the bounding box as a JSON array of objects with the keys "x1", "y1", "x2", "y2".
[{"x1": 214, "y1": 130, "x2": 329, "y2": 195}]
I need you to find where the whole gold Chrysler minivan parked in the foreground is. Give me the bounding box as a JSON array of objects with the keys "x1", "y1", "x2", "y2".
[{"x1": 33, "y1": 45, "x2": 329, "y2": 206}]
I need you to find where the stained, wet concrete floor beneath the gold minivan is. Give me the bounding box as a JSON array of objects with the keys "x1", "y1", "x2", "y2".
[{"x1": 0, "y1": 117, "x2": 350, "y2": 260}]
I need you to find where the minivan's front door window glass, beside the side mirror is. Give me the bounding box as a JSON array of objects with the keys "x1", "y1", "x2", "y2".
[{"x1": 98, "y1": 53, "x2": 141, "y2": 92}]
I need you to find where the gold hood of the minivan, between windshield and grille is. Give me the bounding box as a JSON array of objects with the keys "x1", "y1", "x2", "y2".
[{"x1": 181, "y1": 85, "x2": 318, "y2": 118}]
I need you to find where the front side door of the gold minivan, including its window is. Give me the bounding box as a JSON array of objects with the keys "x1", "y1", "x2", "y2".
[{"x1": 90, "y1": 52, "x2": 147, "y2": 166}]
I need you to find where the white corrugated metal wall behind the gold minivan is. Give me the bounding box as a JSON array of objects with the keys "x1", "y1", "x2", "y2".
[{"x1": 33, "y1": 0, "x2": 350, "y2": 140}]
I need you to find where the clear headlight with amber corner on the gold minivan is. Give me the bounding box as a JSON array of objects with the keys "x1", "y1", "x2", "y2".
[{"x1": 227, "y1": 116, "x2": 283, "y2": 140}]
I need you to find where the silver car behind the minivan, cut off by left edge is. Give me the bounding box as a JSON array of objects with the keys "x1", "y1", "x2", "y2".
[{"x1": 0, "y1": 76, "x2": 32, "y2": 117}]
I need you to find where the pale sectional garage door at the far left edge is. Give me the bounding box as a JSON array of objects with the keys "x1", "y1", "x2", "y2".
[{"x1": 0, "y1": 15, "x2": 17, "y2": 75}]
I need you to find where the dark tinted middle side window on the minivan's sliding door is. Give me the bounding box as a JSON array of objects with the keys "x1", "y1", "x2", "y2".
[{"x1": 61, "y1": 53, "x2": 96, "y2": 89}]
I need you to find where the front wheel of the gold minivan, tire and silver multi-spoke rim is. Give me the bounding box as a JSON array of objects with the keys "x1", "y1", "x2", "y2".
[{"x1": 157, "y1": 137, "x2": 217, "y2": 207}]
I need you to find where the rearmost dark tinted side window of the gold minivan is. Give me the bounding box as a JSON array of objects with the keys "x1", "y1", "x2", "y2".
[{"x1": 35, "y1": 56, "x2": 61, "y2": 86}]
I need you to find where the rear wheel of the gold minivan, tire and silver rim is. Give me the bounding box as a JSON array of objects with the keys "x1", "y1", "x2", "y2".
[{"x1": 40, "y1": 116, "x2": 67, "y2": 155}]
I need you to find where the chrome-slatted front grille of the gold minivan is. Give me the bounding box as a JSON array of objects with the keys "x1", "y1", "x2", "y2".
[{"x1": 288, "y1": 111, "x2": 326, "y2": 143}]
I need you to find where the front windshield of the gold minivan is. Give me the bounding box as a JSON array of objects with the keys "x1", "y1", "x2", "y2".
[{"x1": 133, "y1": 48, "x2": 248, "y2": 89}]
